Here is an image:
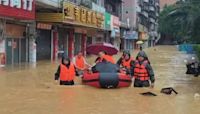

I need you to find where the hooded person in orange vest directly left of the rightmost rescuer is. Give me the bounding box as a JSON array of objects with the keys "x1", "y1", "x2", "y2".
[{"x1": 117, "y1": 52, "x2": 134, "y2": 74}]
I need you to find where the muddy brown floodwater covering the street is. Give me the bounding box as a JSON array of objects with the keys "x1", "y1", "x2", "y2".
[{"x1": 0, "y1": 46, "x2": 200, "y2": 114}]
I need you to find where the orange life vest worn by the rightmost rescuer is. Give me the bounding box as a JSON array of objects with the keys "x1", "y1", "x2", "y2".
[{"x1": 134, "y1": 60, "x2": 149, "y2": 81}]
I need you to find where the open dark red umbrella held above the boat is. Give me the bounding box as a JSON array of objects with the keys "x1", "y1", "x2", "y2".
[{"x1": 86, "y1": 43, "x2": 119, "y2": 55}]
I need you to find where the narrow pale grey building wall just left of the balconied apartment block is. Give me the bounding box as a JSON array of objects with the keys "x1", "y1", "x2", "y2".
[{"x1": 121, "y1": 0, "x2": 138, "y2": 50}]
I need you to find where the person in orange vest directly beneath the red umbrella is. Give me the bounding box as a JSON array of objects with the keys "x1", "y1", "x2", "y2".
[{"x1": 95, "y1": 51, "x2": 115, "y2": 64}]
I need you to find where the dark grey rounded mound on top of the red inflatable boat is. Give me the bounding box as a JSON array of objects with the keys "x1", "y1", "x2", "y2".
[{"x1": 91, "y1": 59, "x2": 120, "y2": 73}]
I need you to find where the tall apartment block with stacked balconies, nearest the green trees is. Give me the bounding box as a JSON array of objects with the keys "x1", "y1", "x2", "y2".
[{"x1": 137, "y1": 0, "x2": 160, "y2": 47}]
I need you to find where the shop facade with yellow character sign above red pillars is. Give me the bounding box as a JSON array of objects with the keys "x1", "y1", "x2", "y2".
[{"x1": 36, "y1": 0, "x2": 105, "y2": 60}]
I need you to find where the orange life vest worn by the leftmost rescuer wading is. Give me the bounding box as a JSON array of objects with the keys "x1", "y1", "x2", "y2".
[{"x1": 60, "y1": 63, "x2": 75, "y2": 81}]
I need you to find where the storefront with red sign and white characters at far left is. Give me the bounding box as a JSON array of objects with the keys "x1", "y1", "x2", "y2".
[{"x1": 0, "y1": 0, "x2": 35, "y2": 66}]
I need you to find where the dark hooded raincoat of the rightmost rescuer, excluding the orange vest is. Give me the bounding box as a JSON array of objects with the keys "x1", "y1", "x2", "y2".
[{"x1": 130, "y1": 51, "x2": 155, "y2": 83}]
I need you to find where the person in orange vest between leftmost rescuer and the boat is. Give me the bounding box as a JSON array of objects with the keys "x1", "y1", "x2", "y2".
[{"x1": 73, "y1": 51, "x2": 91, "y2": 76}]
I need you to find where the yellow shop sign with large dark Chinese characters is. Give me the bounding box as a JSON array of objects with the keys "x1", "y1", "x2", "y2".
[{"x1": 63, "y1": 3, "x2": 104, "y2": 28}]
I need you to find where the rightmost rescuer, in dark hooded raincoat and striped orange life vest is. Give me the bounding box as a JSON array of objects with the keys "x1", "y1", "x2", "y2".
[{"x1": 131, "y1": 51, "x2": 155, "y2": 87}]
